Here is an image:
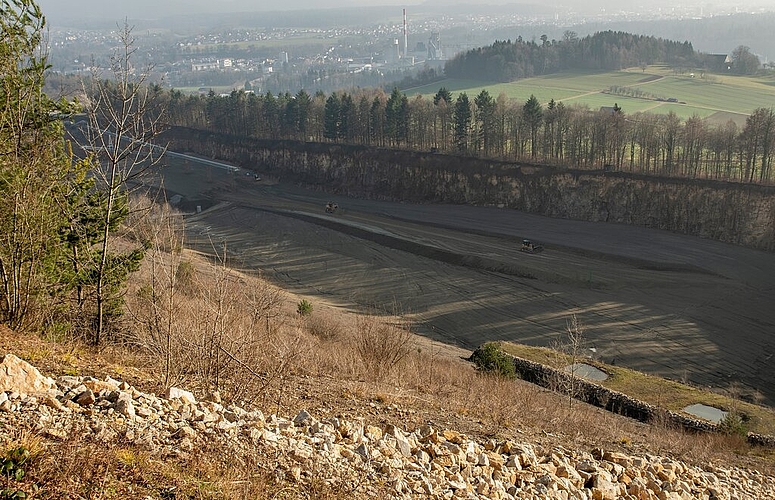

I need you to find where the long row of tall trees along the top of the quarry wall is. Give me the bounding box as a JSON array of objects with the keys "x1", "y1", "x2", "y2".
[{"x1": 167, "y1": 87, "x2": 775, "y2": 183}]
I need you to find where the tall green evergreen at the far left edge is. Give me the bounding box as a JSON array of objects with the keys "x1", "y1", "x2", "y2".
[{"x1": 0, "y1": 0, "x2": 87, "y2": 329}]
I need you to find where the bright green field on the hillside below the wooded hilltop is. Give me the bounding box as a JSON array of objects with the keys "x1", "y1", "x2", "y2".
[{"x1": 406, "y1": 66, "x2": 775, "y2": 123}]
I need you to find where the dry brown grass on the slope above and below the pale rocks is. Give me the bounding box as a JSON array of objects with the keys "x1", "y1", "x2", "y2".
[{"x1": 0, "y1": 228, "x2": 775, "y2": 498}]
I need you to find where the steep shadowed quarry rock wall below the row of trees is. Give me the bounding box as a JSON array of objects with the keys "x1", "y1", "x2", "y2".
[{"x1": 165, "y1": 128, "x2": 775, "y2": 251}]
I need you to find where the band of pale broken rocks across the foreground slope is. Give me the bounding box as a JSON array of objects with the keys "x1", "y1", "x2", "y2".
[{"x1": 0, "y1": 354, "x2": 775, "y2": 500}]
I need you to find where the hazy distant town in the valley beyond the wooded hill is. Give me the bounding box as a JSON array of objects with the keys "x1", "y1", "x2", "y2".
[{"x1": 44, "y1": 4, "x2": 775, "y2": 94}]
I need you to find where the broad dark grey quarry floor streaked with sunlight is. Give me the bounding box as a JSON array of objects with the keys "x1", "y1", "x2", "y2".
[{"x1": 153, "y1": 159, "x2": 775, "y2": 405}]
